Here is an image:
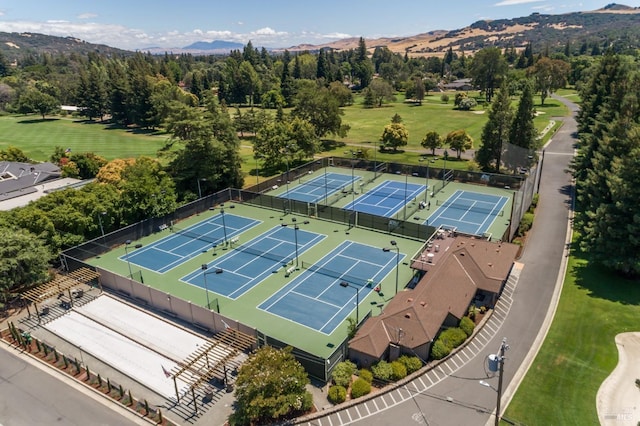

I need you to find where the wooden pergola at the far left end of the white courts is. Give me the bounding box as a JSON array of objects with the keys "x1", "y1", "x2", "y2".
[{"x1": 22, "y1": 268, "x2": 102, "y2": 322}]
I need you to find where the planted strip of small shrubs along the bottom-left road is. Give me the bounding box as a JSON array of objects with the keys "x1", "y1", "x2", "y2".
[{"x1": 0, "y1": 322, "x2": 175, "y2": 426}]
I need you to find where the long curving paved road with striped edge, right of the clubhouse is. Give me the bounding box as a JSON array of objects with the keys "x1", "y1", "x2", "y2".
[{"x1": 305, "y1": 99, "x2": 576, "y2": 426}]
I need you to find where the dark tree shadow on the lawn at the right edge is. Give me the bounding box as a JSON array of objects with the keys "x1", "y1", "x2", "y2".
[{"x1": 570, "y1": 254, "x2": 640, "y2": 305}]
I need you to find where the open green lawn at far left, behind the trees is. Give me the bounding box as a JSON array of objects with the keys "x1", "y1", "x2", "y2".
[{"x1": 0, "y1": 115, "x2": 167, "y2": 161}]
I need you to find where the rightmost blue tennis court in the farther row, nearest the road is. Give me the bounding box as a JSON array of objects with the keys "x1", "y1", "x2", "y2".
[{"x1": 426, "y1": 190, "x2": 509, "y2": 235}]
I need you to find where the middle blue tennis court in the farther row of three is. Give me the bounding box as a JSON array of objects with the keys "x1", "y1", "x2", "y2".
[{"x1": 344, "y1": 180, "x2": 427, "y2": 217}]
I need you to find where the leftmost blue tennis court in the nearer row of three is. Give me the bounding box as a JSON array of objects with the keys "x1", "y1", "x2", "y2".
[{"x1": 119, "y1": 213, "x2": 260, "y2": 274}]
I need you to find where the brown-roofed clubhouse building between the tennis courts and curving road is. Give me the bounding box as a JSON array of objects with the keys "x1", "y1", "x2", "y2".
[{"x1": 349, "y1": 230, "x2": 519, "y2": 367}]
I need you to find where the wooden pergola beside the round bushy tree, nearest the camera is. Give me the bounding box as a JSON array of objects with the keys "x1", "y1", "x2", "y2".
[{"x1": 171, "y1": 328, "x2": 257, "y2": 412}]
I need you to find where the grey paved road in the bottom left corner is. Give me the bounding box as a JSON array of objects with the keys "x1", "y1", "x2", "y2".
[{"x1": 0, "y1": 343, "x2": 148, "y2": 426}]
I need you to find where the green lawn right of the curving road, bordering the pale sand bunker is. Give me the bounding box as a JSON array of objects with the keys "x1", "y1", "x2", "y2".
[{"x1": 505, "y1": 248, "x2": 640, "y2": 425}]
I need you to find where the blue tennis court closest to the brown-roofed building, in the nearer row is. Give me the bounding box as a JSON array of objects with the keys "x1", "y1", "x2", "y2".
[{"x1": 258, "y1": 241, "x2": 404, "y2": 334}]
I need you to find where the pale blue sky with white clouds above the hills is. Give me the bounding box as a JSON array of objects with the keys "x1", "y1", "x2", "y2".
[{"x1": 0, "y1": 0, "x2": 640, "y2": 50}]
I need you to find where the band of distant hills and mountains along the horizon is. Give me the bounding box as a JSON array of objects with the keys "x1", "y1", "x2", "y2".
[{"x1": 0, "y1": 3, "x2": 640, "y2": 62}]
